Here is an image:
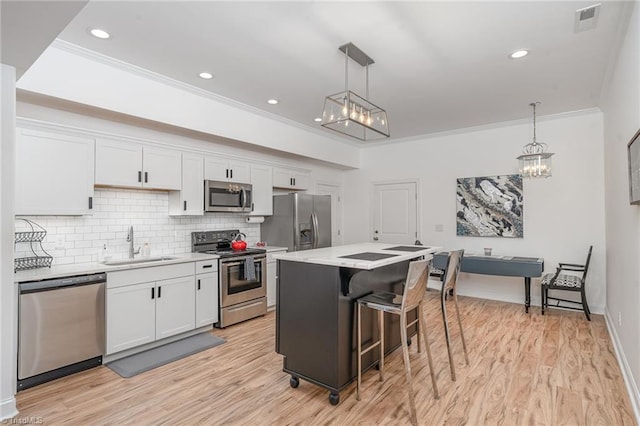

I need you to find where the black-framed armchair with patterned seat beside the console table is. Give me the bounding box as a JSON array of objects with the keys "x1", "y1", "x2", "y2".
[{"x1": 540, "y1": 246, "x2": 593, "y2": 321}]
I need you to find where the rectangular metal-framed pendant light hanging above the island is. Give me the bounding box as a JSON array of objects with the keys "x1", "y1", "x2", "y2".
[{"x1": 322, "y1": 43, "x2": 390, "y2": 141}]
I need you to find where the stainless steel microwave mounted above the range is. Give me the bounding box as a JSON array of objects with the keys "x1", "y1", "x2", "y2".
[{"x1": 204, "y1": 180, "x2": 253, "y2": 213}]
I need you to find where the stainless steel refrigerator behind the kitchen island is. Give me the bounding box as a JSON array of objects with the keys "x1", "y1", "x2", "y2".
[{"x1": 260, "y1": 193, "x2": 331, "y2": 251}]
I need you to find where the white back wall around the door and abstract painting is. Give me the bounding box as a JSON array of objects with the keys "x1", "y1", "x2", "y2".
[{"x1": 344, "y1": 112, "x2": 606, "y2": 313}]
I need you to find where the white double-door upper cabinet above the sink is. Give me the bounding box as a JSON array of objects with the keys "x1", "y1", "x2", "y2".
[{"x1": 95, "y1": 139, "x2": 182, "y2": 190}]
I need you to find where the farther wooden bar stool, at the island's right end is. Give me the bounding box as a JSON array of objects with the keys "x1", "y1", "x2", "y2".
[{"x1": 440, "y1": 249, "x2": 469, "y2": 381}]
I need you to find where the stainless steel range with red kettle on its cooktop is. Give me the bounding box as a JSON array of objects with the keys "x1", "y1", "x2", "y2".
[{"x1": 191, "y1": 229, "x2": 267, "y2": 328}]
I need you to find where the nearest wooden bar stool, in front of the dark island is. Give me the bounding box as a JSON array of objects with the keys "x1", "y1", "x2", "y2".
[{"x1": 356, "y1": 260, "x2": 440, "y2": 424}]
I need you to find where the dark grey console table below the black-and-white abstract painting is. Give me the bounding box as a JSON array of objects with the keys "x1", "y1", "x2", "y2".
[{"x1": 433, "y1": 253, "x2": 544, "y2": 312}]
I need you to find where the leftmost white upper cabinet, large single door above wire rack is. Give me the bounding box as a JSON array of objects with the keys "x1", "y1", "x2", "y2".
[{"x1": 15, "y1": 128, "x2": 94, "y2": 215}]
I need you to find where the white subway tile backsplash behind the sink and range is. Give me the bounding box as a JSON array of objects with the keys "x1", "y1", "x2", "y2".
[{"x1": 16, "y1": 188, "x2": 260, "y2": 265}]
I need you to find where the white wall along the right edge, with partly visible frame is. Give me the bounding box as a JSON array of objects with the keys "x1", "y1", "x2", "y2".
[{"x1": 602, "y1": 2, "x2": 640, "y2": 419}]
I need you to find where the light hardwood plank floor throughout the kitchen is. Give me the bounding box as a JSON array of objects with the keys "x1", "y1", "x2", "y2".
[{"x1": 17, "y1": 291, "x2": 636, "y2": 425}]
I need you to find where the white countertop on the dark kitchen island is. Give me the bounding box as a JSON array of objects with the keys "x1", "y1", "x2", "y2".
[{"x1": 273, "y1": 243, "x2": 442, "y2": 269}]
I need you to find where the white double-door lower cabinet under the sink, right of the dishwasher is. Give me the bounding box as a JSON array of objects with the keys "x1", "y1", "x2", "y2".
[{"x1": 106, "y1": 262, "x2": 196, "y2": 355}]
